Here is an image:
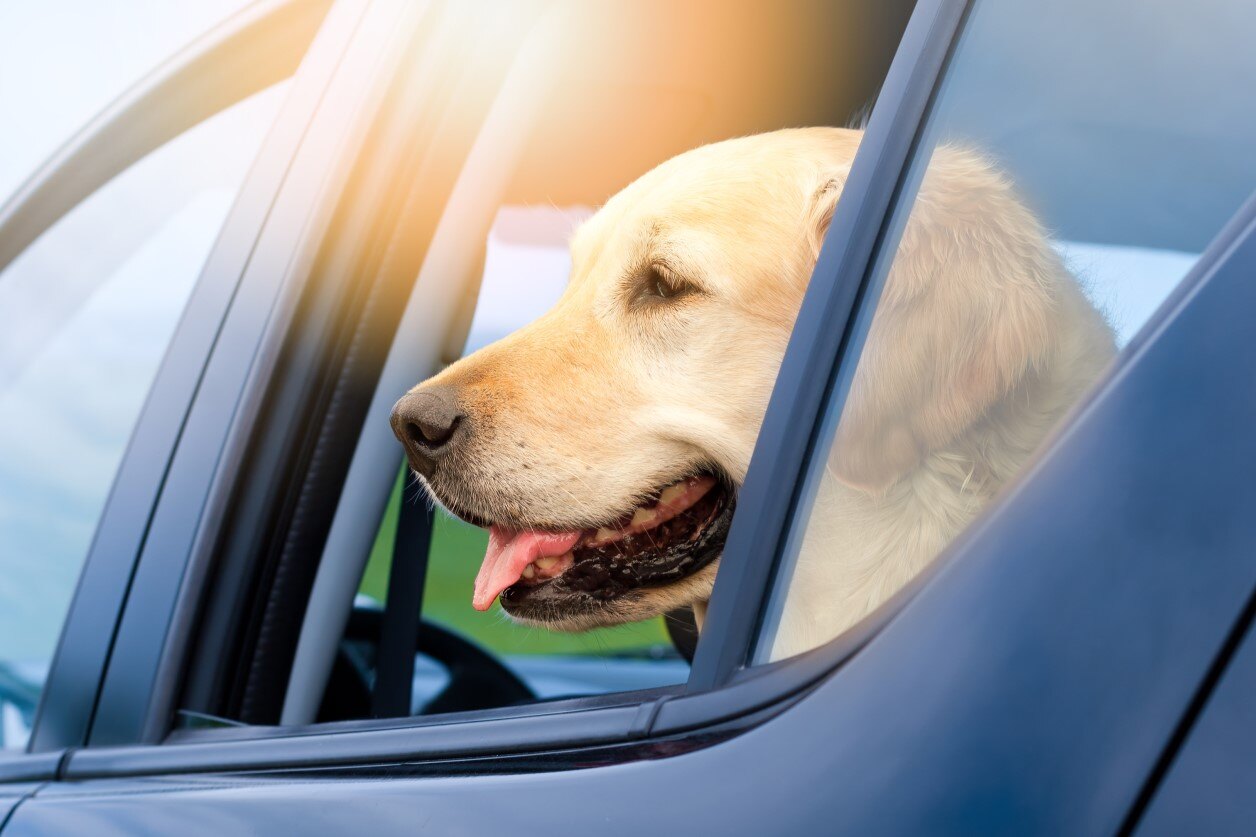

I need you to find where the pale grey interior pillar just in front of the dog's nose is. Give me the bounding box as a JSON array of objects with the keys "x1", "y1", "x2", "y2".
[{"x1": 279, "y1": 3, "x2": 559, "y2": 726}]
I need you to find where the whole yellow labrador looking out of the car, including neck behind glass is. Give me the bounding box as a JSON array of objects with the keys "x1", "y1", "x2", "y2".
[{"x1": 392, "y1": 128, "x2": 1114, "y2": 656}]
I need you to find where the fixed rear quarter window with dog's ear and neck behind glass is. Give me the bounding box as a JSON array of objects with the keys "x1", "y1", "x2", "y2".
[{"x1": 755, "y1": 0, "x2": 1256, "y2": 662}]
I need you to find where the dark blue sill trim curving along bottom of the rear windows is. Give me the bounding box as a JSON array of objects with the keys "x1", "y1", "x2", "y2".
[{"x1": 64, "y1": 192, "x2": 1256, "y2": 779}]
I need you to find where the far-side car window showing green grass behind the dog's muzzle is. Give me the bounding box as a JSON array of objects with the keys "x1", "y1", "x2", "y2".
[{"x1": 359, "y1": 206, "x2": 688, "y2": 704}]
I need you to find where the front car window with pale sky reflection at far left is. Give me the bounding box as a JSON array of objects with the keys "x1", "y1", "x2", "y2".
[{"x1": 0, "y1": 83, "x2": 286, "y2": 748}]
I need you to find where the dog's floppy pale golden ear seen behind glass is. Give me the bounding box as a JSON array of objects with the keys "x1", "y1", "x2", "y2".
[{"x1": 820, "y1": 147, "x2": 1063, "y2": 491}]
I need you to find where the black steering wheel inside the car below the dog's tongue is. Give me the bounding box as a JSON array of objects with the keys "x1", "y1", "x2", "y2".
[{"x1": 319, "y1": 607, "x2": 536, "y2": 723}]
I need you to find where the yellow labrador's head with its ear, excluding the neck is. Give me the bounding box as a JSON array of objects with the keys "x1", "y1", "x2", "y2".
[{"x1": 392, "y1": 128, "x2": 1050, "y2": 630}]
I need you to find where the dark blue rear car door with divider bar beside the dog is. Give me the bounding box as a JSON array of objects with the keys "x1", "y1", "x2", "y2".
[{"x1": 8, "y1": 3, "x2": 1256, "y2": 833}]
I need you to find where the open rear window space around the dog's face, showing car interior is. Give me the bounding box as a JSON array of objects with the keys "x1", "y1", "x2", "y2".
[{"x1": 183, "y1": 3, "x2": 924, "y2": 726}]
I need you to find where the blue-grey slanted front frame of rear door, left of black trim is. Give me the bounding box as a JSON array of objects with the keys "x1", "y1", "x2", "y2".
[{"x1": 78, "y1": 0, "x2": 427, "y2": 747}]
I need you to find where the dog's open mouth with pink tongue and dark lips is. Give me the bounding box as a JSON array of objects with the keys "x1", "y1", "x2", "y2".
[{"x1": 472, "y1": 474, "x2": 734, "y2": 618}]
